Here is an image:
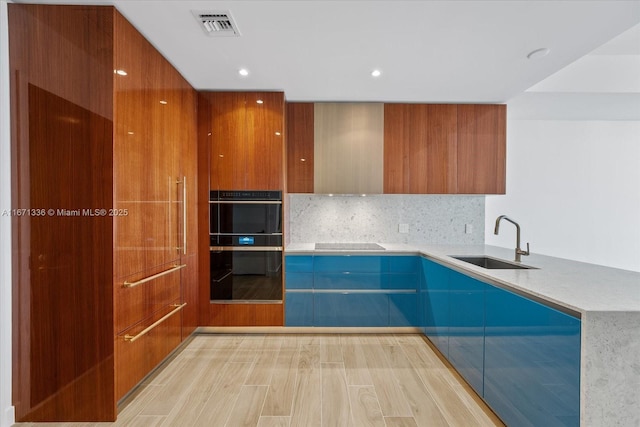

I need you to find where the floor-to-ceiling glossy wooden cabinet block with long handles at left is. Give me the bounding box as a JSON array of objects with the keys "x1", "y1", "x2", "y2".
[{"x1": 9, "y1": 4, "x2": 197, "y2": 421}]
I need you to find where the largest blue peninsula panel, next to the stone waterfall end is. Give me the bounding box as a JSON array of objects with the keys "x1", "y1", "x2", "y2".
[{"x1": 484, "y1": 286, "x2": 580, "y2": 426}]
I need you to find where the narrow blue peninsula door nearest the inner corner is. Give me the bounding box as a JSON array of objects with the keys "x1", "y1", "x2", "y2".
[{"x1": 420, "y1": 258, "x2": 451, "y2": 358}]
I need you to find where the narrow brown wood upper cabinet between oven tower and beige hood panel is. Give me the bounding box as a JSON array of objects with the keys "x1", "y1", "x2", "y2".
[{"x1": 286, "y1": 102, "x2": 314, "y2": 193}]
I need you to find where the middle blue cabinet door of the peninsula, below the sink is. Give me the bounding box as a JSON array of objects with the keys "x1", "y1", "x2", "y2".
[{"x1": 449, "y1": 271, "x2": 487, "y2": 396}]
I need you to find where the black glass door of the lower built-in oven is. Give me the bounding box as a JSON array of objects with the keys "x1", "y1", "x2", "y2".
[{"x1": 211, "y1": 247, "x2": 283, "y2": 302}]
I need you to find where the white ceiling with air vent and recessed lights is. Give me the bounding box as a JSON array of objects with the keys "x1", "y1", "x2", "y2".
[{"x1": 10, "y1": 0, "x2": 640, "y2": 102}]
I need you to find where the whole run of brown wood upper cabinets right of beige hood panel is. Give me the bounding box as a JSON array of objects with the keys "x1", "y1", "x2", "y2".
[{"x1": 384, "y1": 104, "x2": 506, "y2": 194}]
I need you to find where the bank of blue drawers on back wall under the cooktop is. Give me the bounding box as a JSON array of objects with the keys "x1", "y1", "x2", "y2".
[{"x1": 285, "y1": 255, "x2": 421, "y2": 327}]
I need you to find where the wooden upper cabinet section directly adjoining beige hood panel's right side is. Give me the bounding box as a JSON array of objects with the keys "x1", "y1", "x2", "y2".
[{"x1": 384, "y1": 104, "x2": 457, "y2": 194}]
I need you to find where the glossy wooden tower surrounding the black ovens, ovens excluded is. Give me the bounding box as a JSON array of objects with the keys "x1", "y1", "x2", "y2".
[{"x1": 198, "y1": 92, "x2": 285, "y2": 326}]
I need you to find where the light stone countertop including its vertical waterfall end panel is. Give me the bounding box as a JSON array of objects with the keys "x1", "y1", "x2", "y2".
[{"x1": 285, "y1": 243, "x2": 640, "y2": 427}]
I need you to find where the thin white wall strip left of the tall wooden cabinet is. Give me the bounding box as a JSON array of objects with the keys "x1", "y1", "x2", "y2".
[{"x1": 0, "y1": 0, "x2": 14, "y2": 427}]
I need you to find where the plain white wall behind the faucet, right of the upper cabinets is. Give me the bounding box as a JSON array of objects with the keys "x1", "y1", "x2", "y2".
[{"x1": 485, "y1": 119, "x2": 640, "y2": 271}]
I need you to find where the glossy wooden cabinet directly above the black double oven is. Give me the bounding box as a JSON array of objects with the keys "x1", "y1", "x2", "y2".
[{"x1": 199, "y1": 92, "x2": 285, "y2": 191}]
